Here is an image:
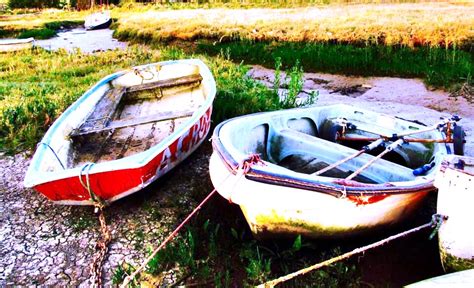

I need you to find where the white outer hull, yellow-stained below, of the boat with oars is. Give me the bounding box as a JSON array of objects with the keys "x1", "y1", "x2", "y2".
[{"x1": 209, "y1": 153, "x2": 428, "y2": 238}]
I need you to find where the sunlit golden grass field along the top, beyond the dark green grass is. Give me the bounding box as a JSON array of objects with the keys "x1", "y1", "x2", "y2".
[{"x1": 115, "y1": 1, "x2": 474, "y2": 49}]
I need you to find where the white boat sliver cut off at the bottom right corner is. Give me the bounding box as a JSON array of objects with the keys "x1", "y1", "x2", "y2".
[{"x1": 405, "y1": 269, "x2": 474, "y2": 288}]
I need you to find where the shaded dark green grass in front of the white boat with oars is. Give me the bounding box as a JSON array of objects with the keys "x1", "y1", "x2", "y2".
[{"x1": 113, "y1": 218, "x2": 361, "y2": 287}]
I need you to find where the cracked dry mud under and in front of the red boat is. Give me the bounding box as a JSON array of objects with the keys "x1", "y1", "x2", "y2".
[{"x1": 0, "y1": 142, "x2": 211, "y2": 287}]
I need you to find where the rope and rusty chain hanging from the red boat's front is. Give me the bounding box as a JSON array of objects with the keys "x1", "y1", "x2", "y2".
[{"x1": 79, "y1": 162, "x2": 112, "y2": 287}]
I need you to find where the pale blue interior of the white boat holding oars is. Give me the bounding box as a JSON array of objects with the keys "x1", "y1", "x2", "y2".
[{"x1": 226, "y1": 105, "x2": 444, "y2": 184}]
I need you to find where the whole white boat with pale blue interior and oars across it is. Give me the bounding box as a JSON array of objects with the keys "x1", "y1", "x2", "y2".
[{"x1": 209, "y1": 105, "x2": 454, "y2": 238}]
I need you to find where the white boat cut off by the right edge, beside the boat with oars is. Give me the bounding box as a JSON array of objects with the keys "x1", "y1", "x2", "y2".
[{"x1": 434, "y1": 155, "x2": 474, "y2": 272}]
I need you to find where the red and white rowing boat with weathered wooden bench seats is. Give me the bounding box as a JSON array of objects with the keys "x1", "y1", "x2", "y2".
[{"x1": 24, "y1": 60, "x2": 216, "y2": 205}]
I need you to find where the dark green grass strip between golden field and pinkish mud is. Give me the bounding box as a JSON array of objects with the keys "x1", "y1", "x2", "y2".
[{"x1": 197, "y1": 41, "x2": 474, "y2": 88}]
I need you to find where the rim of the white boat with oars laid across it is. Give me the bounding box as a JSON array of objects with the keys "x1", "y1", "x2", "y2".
[{"x1": 212, "y1": 108, "x2": 444, "y2": 198}]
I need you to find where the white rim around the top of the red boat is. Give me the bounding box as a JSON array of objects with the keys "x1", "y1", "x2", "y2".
[{"x1": 24, "y1": 59, "x2": 216, "y2": 188}]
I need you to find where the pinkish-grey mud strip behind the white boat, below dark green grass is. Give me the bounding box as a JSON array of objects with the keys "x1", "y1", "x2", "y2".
[{"x1": 248, "y1": 66, "x2": 474, "y2": 156}]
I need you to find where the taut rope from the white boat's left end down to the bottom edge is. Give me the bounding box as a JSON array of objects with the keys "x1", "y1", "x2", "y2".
[{"x1": 120, "y1": 154, "x2": 261, "y2": 288}]
